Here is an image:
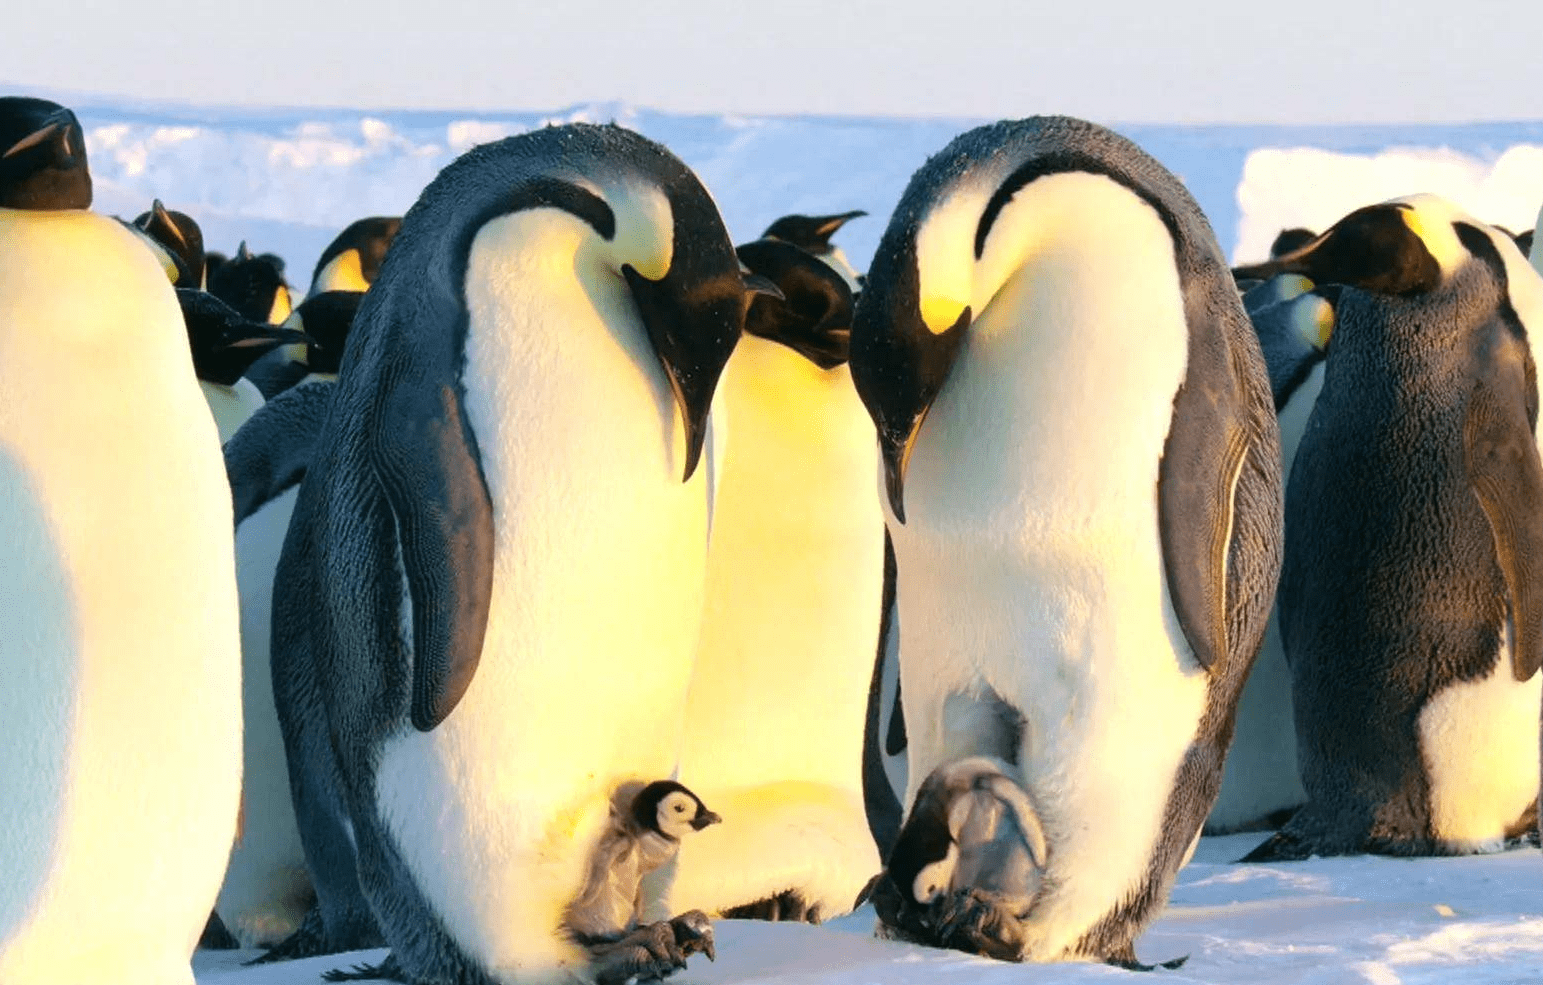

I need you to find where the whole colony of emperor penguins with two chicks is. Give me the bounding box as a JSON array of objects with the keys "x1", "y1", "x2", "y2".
[{"x1": 0, "y1": 97, "x2": 1543, "y2": 985}]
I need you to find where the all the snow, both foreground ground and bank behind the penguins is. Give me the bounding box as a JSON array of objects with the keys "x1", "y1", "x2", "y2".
[{"x1": 39, "y1": 93, "x2": 1543, "y2": 985}]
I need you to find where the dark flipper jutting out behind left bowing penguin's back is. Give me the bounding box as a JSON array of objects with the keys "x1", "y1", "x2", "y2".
[{"x1": 225, "y1": 380, "x2": 335, "y2": 525}]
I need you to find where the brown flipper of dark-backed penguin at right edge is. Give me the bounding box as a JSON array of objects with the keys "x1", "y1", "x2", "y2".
[{"x1": 1463, "y1": 323, "x2": 1543, "y2": 681}]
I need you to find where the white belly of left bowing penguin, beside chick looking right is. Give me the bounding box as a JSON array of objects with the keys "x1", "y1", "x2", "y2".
[{"x1": 376, "y1": 210, "x2": 708, "y2": 980}]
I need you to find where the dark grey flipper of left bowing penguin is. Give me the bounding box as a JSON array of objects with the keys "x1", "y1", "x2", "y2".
[{"x1": 372, "y1": 381, "x2": 494, "y2": 732}]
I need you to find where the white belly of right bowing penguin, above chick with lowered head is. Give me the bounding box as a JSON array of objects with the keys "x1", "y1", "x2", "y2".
[{"x1": 890, "y1": 189, "x2": 1207, "y2": 960}]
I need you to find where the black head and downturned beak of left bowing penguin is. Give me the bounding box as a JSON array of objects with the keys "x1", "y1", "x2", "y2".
[{"x1": 622, "y1": 264, "x2": 749, "y2": 482}]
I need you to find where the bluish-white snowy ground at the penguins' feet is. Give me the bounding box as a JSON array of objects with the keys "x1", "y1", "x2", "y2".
[{"x1": 193, "y1": 834, "x2": 1543, "y2": 985}]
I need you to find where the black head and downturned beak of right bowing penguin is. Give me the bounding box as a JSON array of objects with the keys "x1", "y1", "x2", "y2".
[{"x1": 852, "y1": 258, "x2": 971, "y2": 523}]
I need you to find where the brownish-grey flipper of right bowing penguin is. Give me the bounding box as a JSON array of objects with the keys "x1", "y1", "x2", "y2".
[{"x1": 1157, "y1": 277, "x2": 1282, "y2": 675}]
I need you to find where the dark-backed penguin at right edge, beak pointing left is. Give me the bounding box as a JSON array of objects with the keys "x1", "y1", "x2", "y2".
[{"x1": 1250, "y1": 196, "x2": 1543, "y2": 860}]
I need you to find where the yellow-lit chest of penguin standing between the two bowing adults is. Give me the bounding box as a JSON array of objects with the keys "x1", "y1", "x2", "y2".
[{"x1": 682, "y1": 337, "x2": 884, "y2": 787}]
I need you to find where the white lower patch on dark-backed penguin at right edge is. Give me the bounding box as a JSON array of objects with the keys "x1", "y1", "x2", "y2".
[{"x1": 1420, "y1": 627, "x2": 1543, "y2": 852}]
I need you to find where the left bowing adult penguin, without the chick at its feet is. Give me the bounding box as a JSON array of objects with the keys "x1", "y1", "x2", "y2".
[{"x1": 273, "y1": 125, "x2": 762, "y2": 982}]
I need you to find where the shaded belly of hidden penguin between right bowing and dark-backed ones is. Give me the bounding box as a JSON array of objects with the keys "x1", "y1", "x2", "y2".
[{"x1": 1205, "y1": 363, "x2": 1324, "y2": 834}]
